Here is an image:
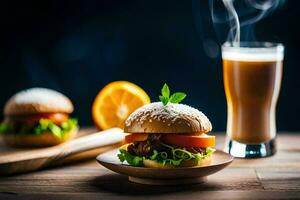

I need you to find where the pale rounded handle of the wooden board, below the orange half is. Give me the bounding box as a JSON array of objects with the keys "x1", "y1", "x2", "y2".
[{"x1": 56, "y1": 128, "x2": 125, "y2": 160}]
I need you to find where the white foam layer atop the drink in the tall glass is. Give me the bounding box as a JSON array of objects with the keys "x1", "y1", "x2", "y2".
[{"x1": 222, "y1": 41, "x2": 284, "y2": 62}]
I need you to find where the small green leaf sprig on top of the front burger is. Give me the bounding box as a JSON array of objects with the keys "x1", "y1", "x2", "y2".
[{"x1": 159, "y1": 83, "x2": 186, "y2": 105}]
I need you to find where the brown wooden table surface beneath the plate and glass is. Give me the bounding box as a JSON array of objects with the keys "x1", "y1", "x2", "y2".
[{"x1": 0, "y1": 133, "x2": 300, "y2": 200}]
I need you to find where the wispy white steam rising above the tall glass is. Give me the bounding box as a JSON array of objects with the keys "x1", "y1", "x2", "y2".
[{"x1": 210, "y1": 0, "x2": 285, "y2": 46}]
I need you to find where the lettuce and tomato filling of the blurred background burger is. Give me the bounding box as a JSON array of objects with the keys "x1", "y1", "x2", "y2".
[{"x1": 0, "y1": 113, "x2": 77, "y2": 138}]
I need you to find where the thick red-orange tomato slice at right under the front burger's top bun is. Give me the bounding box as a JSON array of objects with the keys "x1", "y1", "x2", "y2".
[{"x1": 162, "y1": 134, "x2": 215, "y2": 148}]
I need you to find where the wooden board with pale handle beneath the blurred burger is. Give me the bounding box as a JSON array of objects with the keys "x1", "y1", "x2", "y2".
[{"x1": 0, "y1": 128, "x2": 124, "y2": 176}]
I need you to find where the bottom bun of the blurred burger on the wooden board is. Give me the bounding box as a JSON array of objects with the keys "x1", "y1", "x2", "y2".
[{"x1": 2, "y1": 128, "x2": 78, "y2": 147}]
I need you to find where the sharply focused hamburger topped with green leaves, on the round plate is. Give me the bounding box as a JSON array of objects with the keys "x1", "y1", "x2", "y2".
[{"x1": 118, "y1": 84, "x2": 215, "y2": 169}]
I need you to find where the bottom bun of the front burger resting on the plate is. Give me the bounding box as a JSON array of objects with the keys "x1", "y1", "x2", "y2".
[{"x1": 143, "y1": 155, "x2": 212, "y2": 169}]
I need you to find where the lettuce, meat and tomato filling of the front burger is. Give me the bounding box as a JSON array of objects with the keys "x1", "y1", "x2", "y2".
[{"x1": 118, "y1": 134, "x2": 215, "y2": 166}]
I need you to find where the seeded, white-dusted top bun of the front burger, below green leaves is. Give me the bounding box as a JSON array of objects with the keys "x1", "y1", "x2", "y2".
[{"x1": 124, "y1": 102, "x2": 212, "y2": 134}]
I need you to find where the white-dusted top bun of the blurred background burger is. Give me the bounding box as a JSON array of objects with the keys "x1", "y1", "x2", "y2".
[{"x1": 4, "y1": 88, "x2": 74, "y2": 115}]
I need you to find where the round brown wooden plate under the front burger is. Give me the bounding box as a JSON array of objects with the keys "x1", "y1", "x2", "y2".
[{"x1": 97, "y1": 149, "x2": 233, "y2": 185}]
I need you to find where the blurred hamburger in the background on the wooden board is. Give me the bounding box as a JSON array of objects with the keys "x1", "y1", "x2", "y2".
[{"x1": 0, "y1": 88, "x2": 78, "y2": 147}]
